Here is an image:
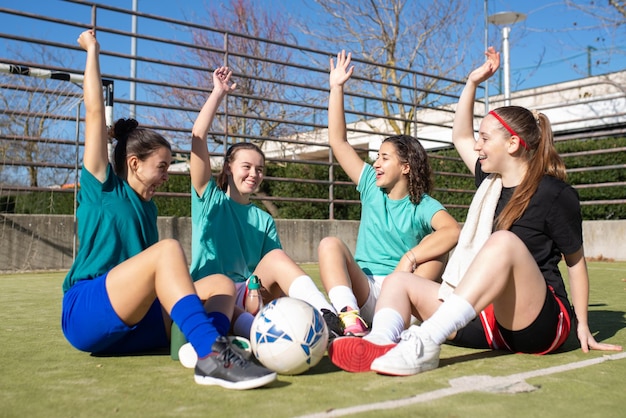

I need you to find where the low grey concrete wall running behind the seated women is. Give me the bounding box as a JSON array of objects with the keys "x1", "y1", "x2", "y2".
[{"x1": 0, "y1": 214, "x2": 626, "y2": 272}]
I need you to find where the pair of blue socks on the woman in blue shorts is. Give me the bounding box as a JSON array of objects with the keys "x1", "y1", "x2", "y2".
[{"x1": 170, "y1": 294, "x2": 230, "y2": 358}]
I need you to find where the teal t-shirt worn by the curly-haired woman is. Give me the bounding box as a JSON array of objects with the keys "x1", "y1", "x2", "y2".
[{"x1": 354, "y1": 164, "x2": 446, "y2": 276}]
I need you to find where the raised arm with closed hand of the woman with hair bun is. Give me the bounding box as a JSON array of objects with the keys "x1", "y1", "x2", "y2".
[{"x1": 78, "y1": 30, "x2": 109, "y2": 182}]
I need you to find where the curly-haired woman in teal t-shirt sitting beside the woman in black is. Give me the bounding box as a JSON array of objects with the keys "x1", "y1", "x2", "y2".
[{"x1": 318, "y1": 51, "x2": 460, "y2": 336}]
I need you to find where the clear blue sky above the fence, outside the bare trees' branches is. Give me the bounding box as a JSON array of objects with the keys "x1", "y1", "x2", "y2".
[{"x1": 0, "y1": 0, "x2": 626, "y2": 94}]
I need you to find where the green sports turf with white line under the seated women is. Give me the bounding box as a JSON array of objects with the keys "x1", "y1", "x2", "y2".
[{"x1": 0, "y1": 262, "x2": 626, "y2": 417}]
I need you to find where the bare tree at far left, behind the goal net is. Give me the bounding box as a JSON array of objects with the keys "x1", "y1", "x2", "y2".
[{"x1": 0, "y1": 46, "x2": 82, "y2": 187}]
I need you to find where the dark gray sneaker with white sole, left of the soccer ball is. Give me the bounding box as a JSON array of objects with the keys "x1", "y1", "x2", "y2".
[{"x1": 194, "y1": 337, "x2": 276, "y2": 390}]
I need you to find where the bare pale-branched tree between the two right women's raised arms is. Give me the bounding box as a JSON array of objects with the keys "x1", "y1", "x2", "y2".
[{"x1": 304, "y1": 0, "x2": 476, "y2": 133}]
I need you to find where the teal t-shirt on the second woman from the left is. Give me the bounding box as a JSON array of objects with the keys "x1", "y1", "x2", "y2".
[{"x1": 191, "y1": 178, "x2": 282, "y2": 282}]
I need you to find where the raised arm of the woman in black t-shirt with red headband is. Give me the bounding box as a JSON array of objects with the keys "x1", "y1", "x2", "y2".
[{"x1": 452, "y1": 47, "x2": 500, "y2": 174}]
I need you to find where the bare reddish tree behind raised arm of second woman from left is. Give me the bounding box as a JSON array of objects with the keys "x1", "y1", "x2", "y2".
[{"x1": 160, "y1": 0, "x2": 307, "y2": 149}]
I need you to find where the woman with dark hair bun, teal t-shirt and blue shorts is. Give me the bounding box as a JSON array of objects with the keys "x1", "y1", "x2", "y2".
[{"x1": 61, "y1": 30, "x2": 276, "y2": 389}]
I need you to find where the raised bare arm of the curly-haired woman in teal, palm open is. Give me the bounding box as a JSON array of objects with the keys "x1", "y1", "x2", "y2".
[{"x1": 328, "y1": 51, "x2": 365, "y2": 184}]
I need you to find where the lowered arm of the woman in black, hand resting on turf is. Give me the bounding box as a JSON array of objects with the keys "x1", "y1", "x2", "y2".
[{"x1": 564, "y1": 248, "x2": 622, "y2": 353}]
